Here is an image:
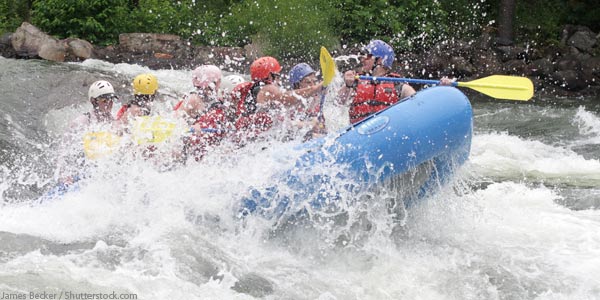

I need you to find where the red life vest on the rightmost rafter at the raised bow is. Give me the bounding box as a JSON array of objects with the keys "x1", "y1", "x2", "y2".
[{"x1": 349, "y1": 74, "x2": 400, "y2": 124}]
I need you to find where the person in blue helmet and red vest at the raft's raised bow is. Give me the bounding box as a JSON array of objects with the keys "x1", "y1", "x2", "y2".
[{"x1": 337, "y1": 40, "x2": 453, "y2": 124}]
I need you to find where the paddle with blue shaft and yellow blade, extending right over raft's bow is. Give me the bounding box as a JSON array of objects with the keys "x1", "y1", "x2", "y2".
[{"x1": 358, "y1": 75, "x2": 533, "y2": 101}]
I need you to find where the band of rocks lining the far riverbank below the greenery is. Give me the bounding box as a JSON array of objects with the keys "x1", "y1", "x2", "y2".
[{"x1": 0, "y1": 23, "x2": 600, "y2": 95}]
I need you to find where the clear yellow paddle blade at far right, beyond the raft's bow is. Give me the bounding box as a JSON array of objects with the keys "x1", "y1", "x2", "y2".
[{"x1": 458, "y1": 75, "x2": 533, "y2": 101}]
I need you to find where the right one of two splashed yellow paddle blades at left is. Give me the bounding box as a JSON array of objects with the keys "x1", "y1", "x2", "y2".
[{"x1": 133, "y1": 116, "x2": 176, "y2": 145}]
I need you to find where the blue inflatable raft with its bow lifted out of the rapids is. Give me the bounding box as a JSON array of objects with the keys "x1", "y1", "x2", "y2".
[{"x1": 240, "y1": 87, "x2": 473, "y2": 218}]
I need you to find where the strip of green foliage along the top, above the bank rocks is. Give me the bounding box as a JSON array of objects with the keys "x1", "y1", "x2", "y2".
[{"x1": 14, "y1": 0, "x2": 600, "y2": 56}]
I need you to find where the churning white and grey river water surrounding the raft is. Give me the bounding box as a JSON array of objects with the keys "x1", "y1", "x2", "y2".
[{"x1": 0, "y1": 57, "x2": 600, "y2": 299}]
